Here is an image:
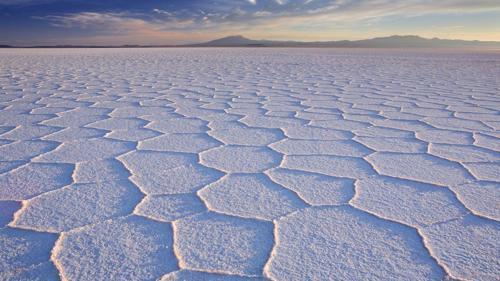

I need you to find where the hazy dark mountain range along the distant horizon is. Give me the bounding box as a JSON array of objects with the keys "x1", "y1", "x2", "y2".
[{"x1": 0, "y1": 35, "x2": 500, "y2": 49}]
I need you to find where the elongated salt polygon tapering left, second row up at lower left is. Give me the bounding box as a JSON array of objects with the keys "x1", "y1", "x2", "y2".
[{"x1": 12, "y1": 181, "x2": 142, "y2": 232}]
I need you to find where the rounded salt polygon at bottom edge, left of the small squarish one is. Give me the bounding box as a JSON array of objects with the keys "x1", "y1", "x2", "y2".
[{"x1": 54, "y1": 216, "x2": 177, "y2": 280}]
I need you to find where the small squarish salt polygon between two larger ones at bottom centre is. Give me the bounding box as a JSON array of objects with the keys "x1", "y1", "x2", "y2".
[{"x1": 174, "y1": 213, "x2": 273, "y2": 275}]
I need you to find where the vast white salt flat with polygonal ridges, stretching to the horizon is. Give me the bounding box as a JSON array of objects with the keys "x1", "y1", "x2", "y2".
[{"x1": 0, "y1": 48, "x2": 500, "y2": 280}]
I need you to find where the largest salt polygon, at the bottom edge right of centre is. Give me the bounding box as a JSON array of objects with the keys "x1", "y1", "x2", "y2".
[{"x1": 266, "y1": 207, "x2": 443, "y2": 280}]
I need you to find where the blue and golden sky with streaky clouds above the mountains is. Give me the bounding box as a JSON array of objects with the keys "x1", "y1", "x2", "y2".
[{"x1": 0, "y1": 0, "x2": 500, "y2": 46}]
